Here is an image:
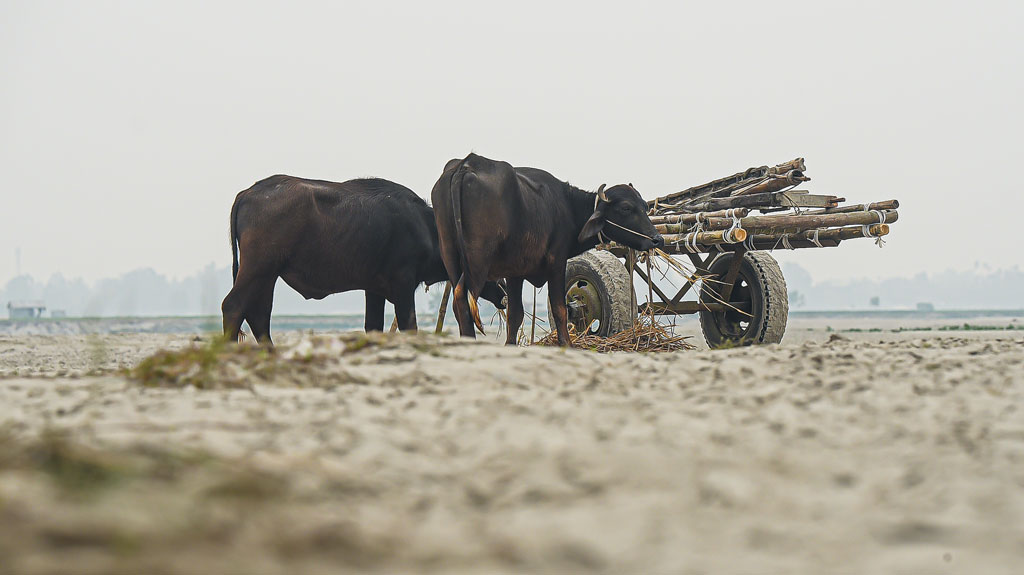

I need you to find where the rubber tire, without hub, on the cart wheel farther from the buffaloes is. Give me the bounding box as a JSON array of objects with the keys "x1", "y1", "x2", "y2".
[{"x1": 698, "y1": 252, "x2": 790, "y2": 349}]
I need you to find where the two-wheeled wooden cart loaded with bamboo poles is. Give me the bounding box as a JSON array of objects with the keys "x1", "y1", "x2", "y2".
[{"x1": 565, "y1": 158, "x2": 899, "y2": 348}]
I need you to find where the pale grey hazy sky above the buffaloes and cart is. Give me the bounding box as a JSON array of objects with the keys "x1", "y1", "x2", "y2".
[{"x1": 0, "y1": 0, "x2": 1024, "y2": 284}]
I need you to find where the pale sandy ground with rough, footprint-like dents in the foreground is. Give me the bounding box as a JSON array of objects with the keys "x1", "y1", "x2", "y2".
[{"x1": 0, "y1": 320, "x2": 1024, "y2": 574}]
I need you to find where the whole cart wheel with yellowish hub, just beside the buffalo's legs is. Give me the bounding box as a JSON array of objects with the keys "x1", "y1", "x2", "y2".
[{"x1": 548, "y1": 250, "x2": 637, "y2": 337}]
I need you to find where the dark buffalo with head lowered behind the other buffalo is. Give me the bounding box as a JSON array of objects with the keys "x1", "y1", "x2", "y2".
[{"x1": 221, "y1": 176, "x2": 505, "y2": 343}]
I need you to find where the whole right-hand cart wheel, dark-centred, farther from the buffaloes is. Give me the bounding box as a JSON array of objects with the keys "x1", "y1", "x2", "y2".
[{"x1": 699, "y1": 252, "x2": 790, "y2": 349}]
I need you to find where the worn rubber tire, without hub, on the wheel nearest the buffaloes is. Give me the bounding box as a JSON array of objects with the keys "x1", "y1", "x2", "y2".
[{"x1": 548, "y1": 250, "x2": 637, "y2": 338}]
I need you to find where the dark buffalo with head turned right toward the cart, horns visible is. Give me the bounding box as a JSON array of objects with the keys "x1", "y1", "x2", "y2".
[{"x1": 431, "y1": 153, "x2": 664, "y2": 346}]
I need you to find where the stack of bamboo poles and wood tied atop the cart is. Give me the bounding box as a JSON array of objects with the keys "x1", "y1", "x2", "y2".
[{"x1": 649, "y1": 158, "x2": 899, "y2": 254}]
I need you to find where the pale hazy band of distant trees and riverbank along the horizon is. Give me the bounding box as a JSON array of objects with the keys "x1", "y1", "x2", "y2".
[{"x1": 0, "y1": 263, "x2": 1024, "y2": 319}]
